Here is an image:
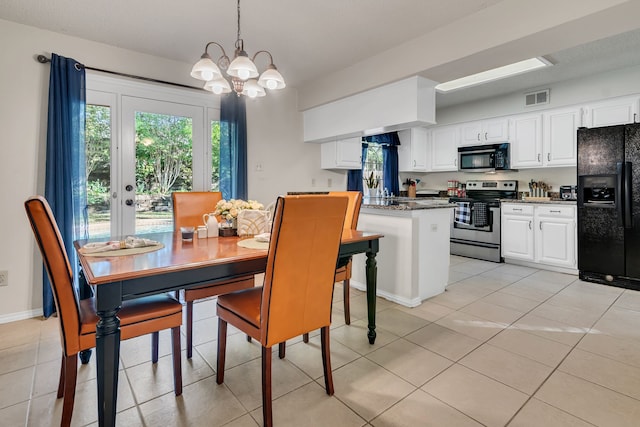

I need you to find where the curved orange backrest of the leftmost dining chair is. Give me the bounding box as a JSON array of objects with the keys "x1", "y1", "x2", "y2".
[{"x1": 24, "y1": 196, "x2": 80, "y2": 354}]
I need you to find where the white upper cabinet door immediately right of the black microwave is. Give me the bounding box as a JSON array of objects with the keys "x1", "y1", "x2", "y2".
[{"x1": 509, "y1": 113, "x2": 543, "y2": 169}]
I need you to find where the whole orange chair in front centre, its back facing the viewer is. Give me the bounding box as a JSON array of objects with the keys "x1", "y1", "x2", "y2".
[{"x1": 216, "y1": 196, "x2": 347, "y2": 427}]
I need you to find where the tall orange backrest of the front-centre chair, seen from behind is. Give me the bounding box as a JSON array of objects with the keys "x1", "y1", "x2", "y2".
[{"x1": 260, "y1": 196, "x2": 347, "y2": 347}]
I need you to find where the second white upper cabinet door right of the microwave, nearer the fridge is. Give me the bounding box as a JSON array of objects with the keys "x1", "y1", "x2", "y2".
[{"x1": 543, "y1": 107, "x2": 582, "y2": 166}]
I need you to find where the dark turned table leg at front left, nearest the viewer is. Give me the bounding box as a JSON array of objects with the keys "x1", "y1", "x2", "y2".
[{"x1": 96, "y1": 283, "x2": 122, "y2": 427}]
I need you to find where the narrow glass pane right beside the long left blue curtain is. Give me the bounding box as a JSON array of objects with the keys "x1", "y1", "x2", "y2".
[{"x1": 85, "y1": 104, "x2": 111, "y2": 238}]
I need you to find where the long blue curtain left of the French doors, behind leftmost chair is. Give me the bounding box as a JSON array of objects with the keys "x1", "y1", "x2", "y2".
[{"x1": 42, "y1": 54, "x2": 87, "y2": 317}]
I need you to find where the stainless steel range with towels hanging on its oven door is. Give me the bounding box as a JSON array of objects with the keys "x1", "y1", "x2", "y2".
[{"x1": 450, "y1": 181, "x2": 518, "y2": 262}]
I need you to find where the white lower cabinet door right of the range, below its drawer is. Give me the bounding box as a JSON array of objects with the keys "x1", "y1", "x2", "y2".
[{"x1": 502, "y1": 214, "x2": 534, "y2": 261}]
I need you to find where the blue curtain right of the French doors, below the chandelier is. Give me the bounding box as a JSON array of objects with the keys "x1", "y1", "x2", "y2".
[{"x1": 220, "y1": 92, "x2": 247, "y2": 200}]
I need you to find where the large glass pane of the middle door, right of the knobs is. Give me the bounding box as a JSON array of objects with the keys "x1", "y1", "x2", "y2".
[{"x1": 135, "y1": 111, "x2": 193, "y2": 233}]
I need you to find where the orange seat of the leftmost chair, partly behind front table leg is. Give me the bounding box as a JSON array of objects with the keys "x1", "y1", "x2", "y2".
[{"x1": 80, "y1": 294, "x2": 182, "y2": 335}]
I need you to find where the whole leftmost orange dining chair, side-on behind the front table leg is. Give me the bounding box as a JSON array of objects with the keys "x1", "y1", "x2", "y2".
[{"x1": 24, "y1": 196, "x2": 182, "y2": 426}]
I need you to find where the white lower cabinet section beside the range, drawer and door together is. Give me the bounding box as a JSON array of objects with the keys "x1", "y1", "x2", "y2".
[{"x1": 501, "y1": 203, "x2": 535, "y2": 261}]
